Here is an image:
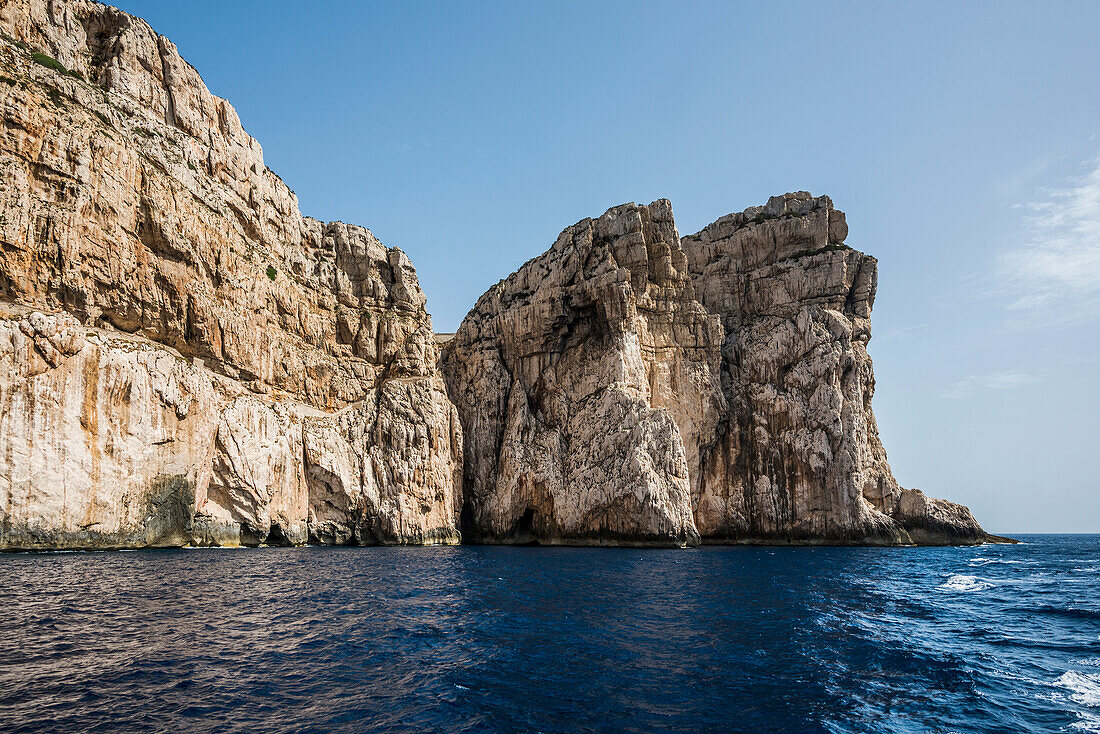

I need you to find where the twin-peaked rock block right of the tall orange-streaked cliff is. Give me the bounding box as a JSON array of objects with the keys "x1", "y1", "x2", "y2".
[{"x1": 442, "y1": 193, "x2": 987, "y2": 544}]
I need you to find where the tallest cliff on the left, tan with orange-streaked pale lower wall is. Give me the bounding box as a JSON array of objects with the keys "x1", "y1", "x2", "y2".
[{"x1": 0, "y1": 0, "x2": 461, "y2": 547}]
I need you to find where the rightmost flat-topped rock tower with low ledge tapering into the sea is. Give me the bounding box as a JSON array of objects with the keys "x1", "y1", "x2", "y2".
[{"x1": 682, "y1": 191, "x2": 985, "y2": 543}]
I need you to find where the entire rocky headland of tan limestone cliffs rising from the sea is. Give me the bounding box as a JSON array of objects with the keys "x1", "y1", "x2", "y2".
[{"x1": 0, "y1": 0, "x2": 991, "y2": 549}]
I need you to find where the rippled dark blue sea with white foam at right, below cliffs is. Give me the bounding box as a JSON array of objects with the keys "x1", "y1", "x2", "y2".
[{"x1": 0, "y1": 536, "x2": 1100, "y2": 734}]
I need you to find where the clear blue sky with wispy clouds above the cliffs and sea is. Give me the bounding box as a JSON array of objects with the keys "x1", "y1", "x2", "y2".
[{"x1": 117, "y1": 0, "x2": 1100, "y2": 533}]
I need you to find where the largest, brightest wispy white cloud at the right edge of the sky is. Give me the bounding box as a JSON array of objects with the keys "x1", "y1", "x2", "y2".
[{"x1": 999, "y1": 160, "x2": 1100, "y2": 321}]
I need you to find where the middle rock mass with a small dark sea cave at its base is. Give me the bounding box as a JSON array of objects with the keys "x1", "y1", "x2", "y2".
[{"x1": 443, "y1": 201, "x2": 724, "y2": 545}]
